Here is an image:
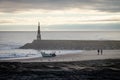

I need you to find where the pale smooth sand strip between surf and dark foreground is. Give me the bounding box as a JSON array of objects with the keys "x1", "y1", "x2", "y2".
[{"x1": 1, "y1": 50, "x2": 120, "y2": 62}]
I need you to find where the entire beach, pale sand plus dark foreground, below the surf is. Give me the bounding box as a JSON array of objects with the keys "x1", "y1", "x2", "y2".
[{"x1": 0, "y1": 50, "x2": 120, "y2": 80}]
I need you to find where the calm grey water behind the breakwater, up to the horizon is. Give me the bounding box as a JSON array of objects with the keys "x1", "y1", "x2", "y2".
[{"x1": 0, "y1": 31, "x2": 120, "y2": 49}]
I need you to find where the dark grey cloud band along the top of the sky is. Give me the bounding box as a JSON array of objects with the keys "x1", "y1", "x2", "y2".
[{"x1": 0, "y1": 0, "x2": 120, "y2": 12}]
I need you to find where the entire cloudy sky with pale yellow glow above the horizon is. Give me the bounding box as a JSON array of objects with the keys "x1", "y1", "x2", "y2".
[{"x1": 0, "y1": 0, "x2": 120, "y2": 31}]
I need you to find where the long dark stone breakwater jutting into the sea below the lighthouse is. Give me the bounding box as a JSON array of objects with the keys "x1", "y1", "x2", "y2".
[{"x1": 20, "y1": 40, "x2": 120, "y2": 50}]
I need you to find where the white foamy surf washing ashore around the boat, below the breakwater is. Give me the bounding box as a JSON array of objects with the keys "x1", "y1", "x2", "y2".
[{"x1": 0, "y1": 49, "x2": 82, "y2": 60}]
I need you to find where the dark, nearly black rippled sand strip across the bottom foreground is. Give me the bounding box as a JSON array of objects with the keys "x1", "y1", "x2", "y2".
[{"x1": 0, "y1": 59, "x2": 120, "y2": 80}]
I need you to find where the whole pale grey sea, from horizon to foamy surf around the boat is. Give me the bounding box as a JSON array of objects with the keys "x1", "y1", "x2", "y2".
[{"x1": 0, "y1": 31, "x2": 120, "y2": 60}]
